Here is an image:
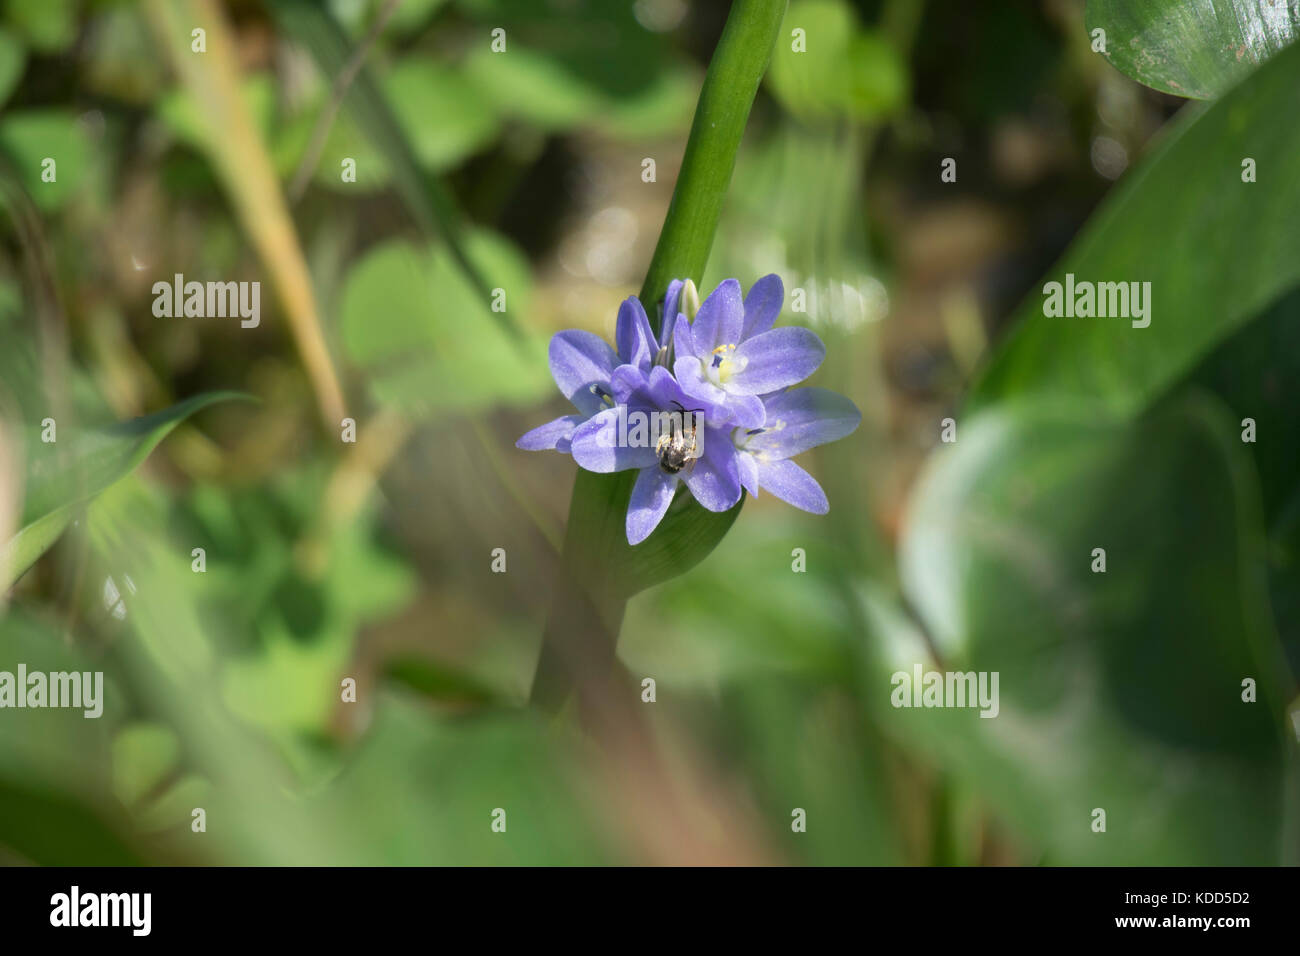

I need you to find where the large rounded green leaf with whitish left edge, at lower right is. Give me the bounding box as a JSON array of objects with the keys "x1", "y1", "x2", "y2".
[{"x1": 894, "y1": 401, "x2": 1287, "y2": 865}]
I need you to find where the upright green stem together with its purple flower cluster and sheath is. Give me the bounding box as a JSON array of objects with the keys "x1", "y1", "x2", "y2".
[{"x1": 519, "y1": 0, "x2": 790, "y2": 711}]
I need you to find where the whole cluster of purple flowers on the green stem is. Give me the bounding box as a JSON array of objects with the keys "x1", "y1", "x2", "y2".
[{"x1": 517, "y1": 274, "x2": 861, "y2": 545}]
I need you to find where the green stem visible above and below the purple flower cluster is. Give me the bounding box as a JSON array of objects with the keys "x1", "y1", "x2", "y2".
[{"x1": 532, "y1": 0, "x2": 787, "y2": 713}]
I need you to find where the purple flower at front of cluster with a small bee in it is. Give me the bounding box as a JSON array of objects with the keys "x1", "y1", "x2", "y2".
[{"x1": 571, "y1": 365, "x2": 740, "y2": 545}]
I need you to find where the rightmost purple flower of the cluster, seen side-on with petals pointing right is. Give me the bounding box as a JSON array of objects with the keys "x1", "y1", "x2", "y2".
[{"x1": 732, "y1": 389, "x2": 862, "y2": 515}]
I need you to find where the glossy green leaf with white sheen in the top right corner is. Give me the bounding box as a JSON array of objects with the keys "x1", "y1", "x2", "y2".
[{"x1": 1084, "y1": 0, "x2": 1300, "y2": 100}]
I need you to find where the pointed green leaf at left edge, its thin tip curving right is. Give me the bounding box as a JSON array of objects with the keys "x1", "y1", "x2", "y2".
[{"x1": 0, "y1": 392, "x2": 241, "y2": 591}]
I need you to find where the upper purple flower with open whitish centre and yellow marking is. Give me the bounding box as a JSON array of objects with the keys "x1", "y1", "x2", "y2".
[{"x1": 666, "y1": 274, "x2": 826, "y2": 428}]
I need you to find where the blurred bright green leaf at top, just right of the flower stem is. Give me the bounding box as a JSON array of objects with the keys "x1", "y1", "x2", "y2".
[{"x1": 768, "y1": 0, "x2": 907, "y2": 122}]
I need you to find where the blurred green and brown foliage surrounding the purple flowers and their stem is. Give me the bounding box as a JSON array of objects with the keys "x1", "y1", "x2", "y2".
[{"x1": 0, "y1": 0, "x2": 1300, "y2": 864}]
